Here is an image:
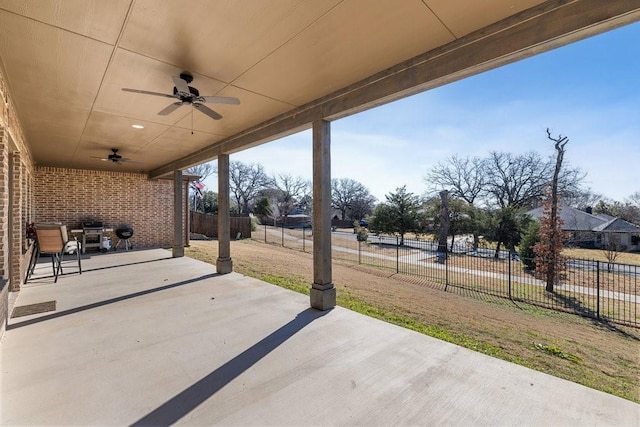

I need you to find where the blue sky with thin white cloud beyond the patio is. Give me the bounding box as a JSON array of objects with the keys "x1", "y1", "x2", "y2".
[{"x1": 205, "y1": 23, "x2": 640, "y2": 205}]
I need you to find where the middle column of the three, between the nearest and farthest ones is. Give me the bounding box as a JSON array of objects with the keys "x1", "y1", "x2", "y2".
[{"x1": 216, "y1": 154, "x2": 233, "y2": 274}]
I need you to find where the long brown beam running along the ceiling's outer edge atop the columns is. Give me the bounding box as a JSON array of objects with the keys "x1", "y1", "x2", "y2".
[{"x1": 149, "y1": 0, "x2": 640, "y2": 179}]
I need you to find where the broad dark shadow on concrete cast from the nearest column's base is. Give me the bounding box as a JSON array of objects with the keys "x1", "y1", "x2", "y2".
[{"x1": 132, "y1": 308, "x2": 330, "y2": 426}]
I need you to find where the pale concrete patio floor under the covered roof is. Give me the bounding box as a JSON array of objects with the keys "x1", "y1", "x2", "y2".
[{"x1": 0, "y1": 249, "x2": 640, "y2": 426}]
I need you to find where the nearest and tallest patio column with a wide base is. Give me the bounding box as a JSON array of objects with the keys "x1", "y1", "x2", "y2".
[{"x1": 310, "y1": 120, "x2": 336, "y2": 310}]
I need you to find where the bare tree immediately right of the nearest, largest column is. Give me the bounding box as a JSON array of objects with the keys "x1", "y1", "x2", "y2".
[{"x1": 331, "y1": 178, "x2": 375, "y2": 220}]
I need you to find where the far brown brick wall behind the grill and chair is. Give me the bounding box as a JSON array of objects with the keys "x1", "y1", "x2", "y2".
[{"x1": 34, "y1": 167, "x2": 184, "y2": 248}]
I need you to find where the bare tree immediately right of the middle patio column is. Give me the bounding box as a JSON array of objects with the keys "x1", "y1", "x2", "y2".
[{"x1": 229, "y1": 161, "x2": 271, "y2": 214}]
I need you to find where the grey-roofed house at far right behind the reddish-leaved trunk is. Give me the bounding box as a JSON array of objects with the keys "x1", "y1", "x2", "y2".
[{"x1": 527, "y1": 206, "x2": 640, "y2": 251}]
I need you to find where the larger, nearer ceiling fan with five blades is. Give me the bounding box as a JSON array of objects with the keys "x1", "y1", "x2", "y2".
[{"x1": 122, "y1": 71, "x2": 240, "y2": 120}]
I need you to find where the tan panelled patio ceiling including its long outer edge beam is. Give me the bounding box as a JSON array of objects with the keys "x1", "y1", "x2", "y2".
[{"x1": 0, "y1": 0, "x2": 640, "y2": 178}]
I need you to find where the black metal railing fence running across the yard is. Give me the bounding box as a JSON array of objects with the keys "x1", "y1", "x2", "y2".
[{"x1": 256, "y1": 227, "x2": 640, "y2": 327}]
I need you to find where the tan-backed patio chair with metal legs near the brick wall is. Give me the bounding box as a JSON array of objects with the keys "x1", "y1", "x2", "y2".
[{"x1": 33, "y1": 224, "x2": 82, "y2": 283}]
